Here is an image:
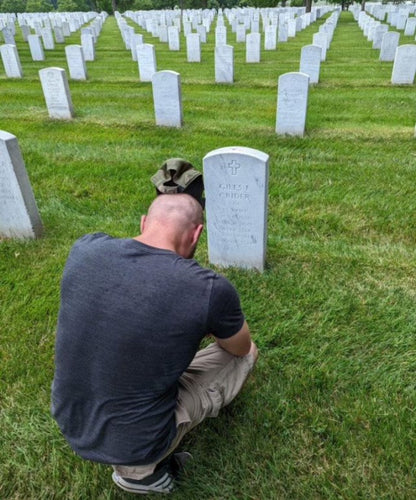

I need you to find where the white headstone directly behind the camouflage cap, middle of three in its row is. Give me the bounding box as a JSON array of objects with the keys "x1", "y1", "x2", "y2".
[{"x1": 152, "y1": 71, "x2": 183, "y2": 128}]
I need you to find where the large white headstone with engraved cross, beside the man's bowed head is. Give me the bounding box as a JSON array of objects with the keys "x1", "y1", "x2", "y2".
[{"x1": 203, "y1": 147, "x2": 269, "y2": 271}]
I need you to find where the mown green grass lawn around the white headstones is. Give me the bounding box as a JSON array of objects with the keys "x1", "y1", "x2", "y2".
[{"x1": 0, "y1": 13, "x2": 416, "y2": 500}]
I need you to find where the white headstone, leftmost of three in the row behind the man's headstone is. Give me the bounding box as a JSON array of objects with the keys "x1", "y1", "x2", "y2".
[{"x1": 39, "y1": 68, "x2": 74, "y2": 120}]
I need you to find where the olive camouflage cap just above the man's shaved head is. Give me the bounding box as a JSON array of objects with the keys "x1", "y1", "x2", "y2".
[{"x1": 151, "y1": 158, "x2": 205, "y2": 208}]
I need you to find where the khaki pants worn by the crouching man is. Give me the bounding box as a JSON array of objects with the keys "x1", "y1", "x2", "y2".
[{"x1": 113, "y1": 343, "x2": 255, "y2": 479}]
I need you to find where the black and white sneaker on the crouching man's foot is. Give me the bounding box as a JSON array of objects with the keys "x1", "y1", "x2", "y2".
[{"x1": 111, "y1": 451, "x2": 192, "y2": 495}]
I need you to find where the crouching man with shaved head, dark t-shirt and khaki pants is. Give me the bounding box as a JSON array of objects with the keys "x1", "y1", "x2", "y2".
[{"x1": 52, "y1": 194, "x2": 257, "y2": 493}]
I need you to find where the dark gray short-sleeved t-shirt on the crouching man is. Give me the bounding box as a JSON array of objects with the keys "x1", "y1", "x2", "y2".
[{"x1": 52, "y1": 233, "x2": 244, "y2": 465}]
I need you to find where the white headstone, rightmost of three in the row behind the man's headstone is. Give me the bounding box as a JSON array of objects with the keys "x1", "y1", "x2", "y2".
[{"x1": 276, "y1": 73, "x2": 309, "y2": 137}]
